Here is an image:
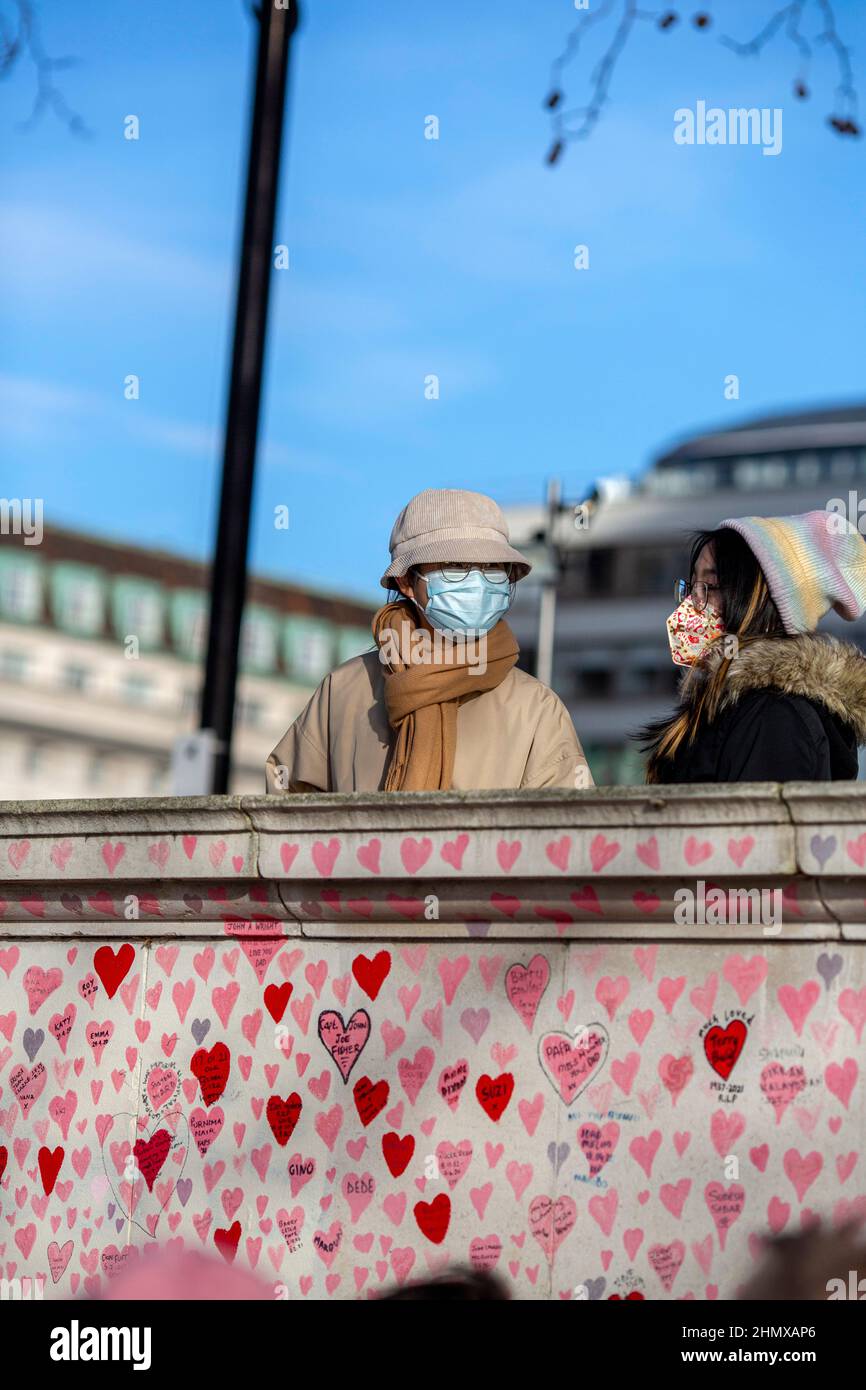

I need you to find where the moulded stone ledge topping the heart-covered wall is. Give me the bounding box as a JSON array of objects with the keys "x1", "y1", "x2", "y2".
[{"x1": 0, "y1": 783, "x2": 866, "y2": 945}]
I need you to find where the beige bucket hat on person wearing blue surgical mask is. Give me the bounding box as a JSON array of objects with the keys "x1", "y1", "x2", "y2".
[{"x1": 379, "y1": 488, "x2": 532, "y2": 589}]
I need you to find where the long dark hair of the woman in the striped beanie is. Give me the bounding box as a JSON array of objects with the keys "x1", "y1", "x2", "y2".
[{"x1": 634, "y1": 527, "x2": 785, "y2": 783}]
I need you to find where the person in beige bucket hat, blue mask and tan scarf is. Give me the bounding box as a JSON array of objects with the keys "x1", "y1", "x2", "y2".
[{"x1": 267, "y1": 488, "x2": 592, "y2": 792}]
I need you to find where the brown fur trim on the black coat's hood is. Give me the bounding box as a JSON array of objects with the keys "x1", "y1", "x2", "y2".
[{"x1": 681, "y1": 632, "x2": 866, "y2": 744}]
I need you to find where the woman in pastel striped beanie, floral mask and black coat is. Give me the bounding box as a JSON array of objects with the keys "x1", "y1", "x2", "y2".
[{"x1": 638, "y1": 512, "x2": 866, "y2": 783}]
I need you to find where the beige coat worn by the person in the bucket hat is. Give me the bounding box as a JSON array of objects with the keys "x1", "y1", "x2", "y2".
[{"x1": 265, "y1": 651, "x2": 594, "y2": 792}]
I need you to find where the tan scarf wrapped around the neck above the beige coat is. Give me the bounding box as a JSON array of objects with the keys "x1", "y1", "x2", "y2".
[{"x1": 373, "y1": 599, "x2": 520, "y2": 791}]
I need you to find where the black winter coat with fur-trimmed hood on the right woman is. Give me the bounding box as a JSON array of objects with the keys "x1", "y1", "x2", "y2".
[{"x1": 650, "y1": 634, "x2": 866, "y2": 783}]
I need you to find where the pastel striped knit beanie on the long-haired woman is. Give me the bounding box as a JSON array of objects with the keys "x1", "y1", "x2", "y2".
[{"x1": 720, "y1": 512, "x2": 866, "y2": 634}]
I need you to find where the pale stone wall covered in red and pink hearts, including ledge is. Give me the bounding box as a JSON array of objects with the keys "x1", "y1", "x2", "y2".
[{"x1": 0, "y1": 785, "x2": 866, "y2": 1300}]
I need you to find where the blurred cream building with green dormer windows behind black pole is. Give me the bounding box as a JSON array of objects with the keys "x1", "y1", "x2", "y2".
[{"x1": 0, "y1": 528, "x2": 371, "y2": 801}]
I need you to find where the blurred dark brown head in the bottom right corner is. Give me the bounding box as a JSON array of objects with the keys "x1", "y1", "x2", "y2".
[{"x1": 740, "y1": 1220, "x2": 866, "y2": 1302}]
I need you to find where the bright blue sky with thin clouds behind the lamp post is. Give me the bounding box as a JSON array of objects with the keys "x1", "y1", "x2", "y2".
[{"x1": 0, "y1": 0, "x2": 866, "y2": 596}]
